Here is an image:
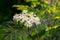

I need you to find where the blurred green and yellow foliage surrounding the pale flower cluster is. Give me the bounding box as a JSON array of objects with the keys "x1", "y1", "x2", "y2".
[{"x1": 0, "y1": 0, "x2": 60, "y2": 40}]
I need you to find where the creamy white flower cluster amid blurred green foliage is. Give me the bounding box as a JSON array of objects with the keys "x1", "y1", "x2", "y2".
[{"x1": 13, "y1": 10, "x2": 41, "y2": 27}]
